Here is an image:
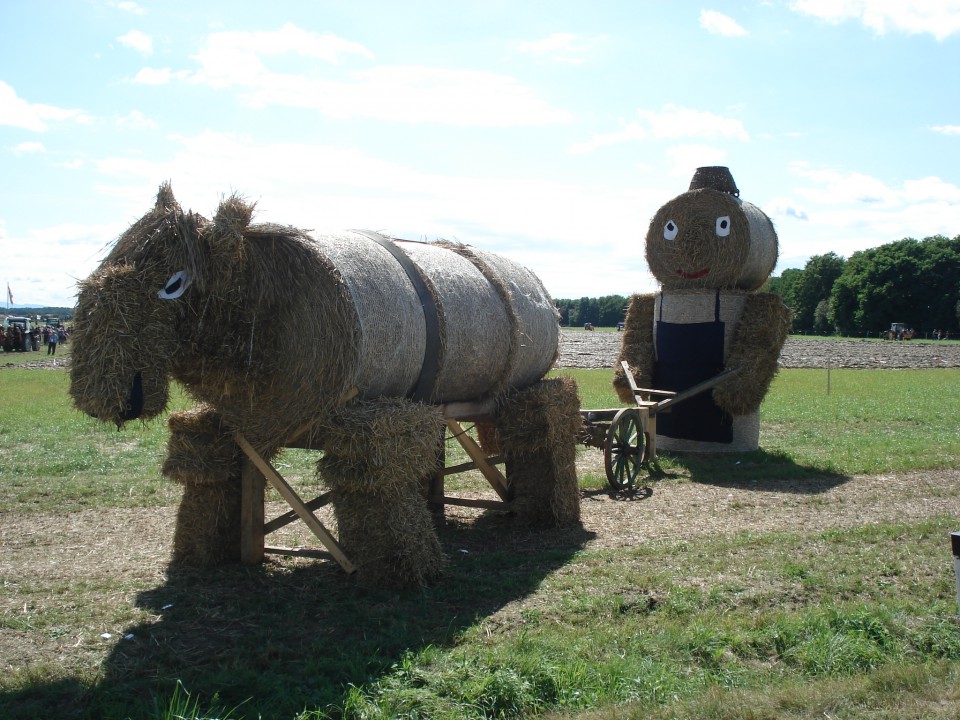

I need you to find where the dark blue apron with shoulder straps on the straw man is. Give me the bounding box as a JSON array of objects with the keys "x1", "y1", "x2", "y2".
[{"x1": 653, "y1": 290, "x2": 733, "y2": 443}]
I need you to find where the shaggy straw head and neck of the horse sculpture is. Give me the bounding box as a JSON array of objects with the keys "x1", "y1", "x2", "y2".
[{"x1": 70, "y1": 184, "x2": 356, "y2": 426}]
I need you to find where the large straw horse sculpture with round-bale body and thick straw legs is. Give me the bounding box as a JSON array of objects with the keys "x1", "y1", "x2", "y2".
[{"x1": 70, "y1": 184, "x2": 580, "y2": 585}]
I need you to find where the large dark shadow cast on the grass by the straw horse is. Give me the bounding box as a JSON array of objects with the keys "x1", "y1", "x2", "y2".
[{"x1": 0, "y1": 514, "x2": 592, "y2": 719}]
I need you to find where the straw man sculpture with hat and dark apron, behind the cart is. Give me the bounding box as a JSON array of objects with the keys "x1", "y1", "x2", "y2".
[{"x1": 614, "y1": 167, "x2": 790, "y2": 452}]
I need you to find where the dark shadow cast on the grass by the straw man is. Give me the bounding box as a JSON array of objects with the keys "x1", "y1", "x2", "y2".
[{"x1": 661, "y1": 449, "x2": 851, "y2": 495}]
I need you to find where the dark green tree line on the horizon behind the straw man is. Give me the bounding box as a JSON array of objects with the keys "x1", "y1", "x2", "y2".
[{"x1": 554, "y1": 235, "x2": 960, "y2": 337}]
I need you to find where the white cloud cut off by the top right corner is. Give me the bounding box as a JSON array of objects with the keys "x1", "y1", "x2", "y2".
[{"x1": 790, "y1": 0, "x2": 960, "y2": 40}]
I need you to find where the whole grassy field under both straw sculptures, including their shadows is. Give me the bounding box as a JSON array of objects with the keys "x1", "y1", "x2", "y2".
[{"x1": 0, "y1": 360, "x2": 960, "y2": 720}]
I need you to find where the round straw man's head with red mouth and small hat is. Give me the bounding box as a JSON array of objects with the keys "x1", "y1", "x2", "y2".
[{"x1": 646, "y1": 167, "x2": 777, "y2": 291}]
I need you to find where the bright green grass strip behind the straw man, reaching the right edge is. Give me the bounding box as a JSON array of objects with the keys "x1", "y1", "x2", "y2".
[{"x1": 562, "y1": 369, "x2": 960, "y2": 487}]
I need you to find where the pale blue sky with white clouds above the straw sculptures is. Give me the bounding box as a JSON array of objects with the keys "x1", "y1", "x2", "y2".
[{"x1": 0, "y1": 0, "x2": 960, "y2": 305}]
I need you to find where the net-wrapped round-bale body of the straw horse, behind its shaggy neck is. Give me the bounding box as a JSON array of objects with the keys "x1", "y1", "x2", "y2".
[{"x1": 315, "y1": 232, "x2": 559, "y2": 403}]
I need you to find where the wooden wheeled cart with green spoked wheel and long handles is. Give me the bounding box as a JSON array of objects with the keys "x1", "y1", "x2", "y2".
[{"x1": 579, "y1": 361, "x2": 740, "y2": 491}]
